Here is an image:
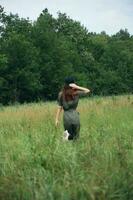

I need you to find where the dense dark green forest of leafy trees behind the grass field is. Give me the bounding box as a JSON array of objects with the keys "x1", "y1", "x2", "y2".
[{"x1": 0, "y1": 6, "x2": 133, "y2": 105}]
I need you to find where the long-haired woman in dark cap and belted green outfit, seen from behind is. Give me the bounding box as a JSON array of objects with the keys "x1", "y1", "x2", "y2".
[{"x1": 55, "y1": 77, "x2": 90, "y2": 140}]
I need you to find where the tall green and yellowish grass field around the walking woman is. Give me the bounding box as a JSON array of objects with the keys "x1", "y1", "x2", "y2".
[{"x1": 0, "y1": 95, "x2": 133, "y2": 200}]
